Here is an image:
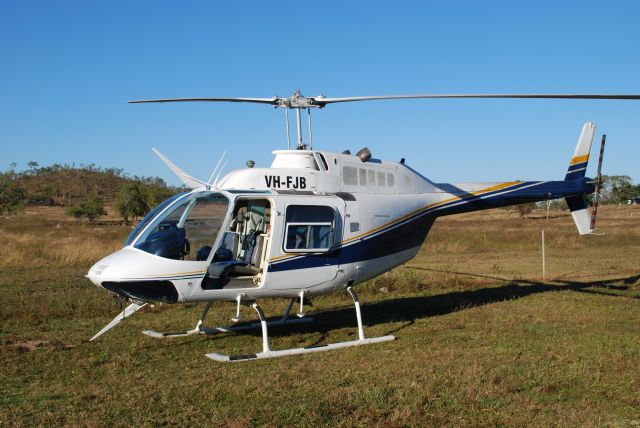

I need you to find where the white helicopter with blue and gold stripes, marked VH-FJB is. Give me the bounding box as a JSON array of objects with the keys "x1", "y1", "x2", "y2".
[{"x1": 87, "y1": 91, "x2": 640, "y2": 361}]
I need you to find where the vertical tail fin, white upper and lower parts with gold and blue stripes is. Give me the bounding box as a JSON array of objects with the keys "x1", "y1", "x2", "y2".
[{"x1": 564, "y1": 122, "x2": 596, "y2": 235}]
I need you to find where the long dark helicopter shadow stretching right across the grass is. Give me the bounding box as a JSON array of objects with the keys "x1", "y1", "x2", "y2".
[{"x1": 215, "y1": 274, "x2": 640, "y2": 342}]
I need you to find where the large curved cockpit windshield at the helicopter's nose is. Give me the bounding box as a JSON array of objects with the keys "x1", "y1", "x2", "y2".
[{"x1": 132, "y1": 191, "x2": 229, "y2": 261}]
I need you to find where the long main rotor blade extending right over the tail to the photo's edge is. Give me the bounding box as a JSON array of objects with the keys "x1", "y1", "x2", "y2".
[{"x1": 313, "y1": 94, "x2": 640, "y2": 107}]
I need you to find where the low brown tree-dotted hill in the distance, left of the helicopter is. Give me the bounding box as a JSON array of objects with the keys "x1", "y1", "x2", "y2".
[{"x1": 3, "y1": 162, "x2": 184, "y2": 207}]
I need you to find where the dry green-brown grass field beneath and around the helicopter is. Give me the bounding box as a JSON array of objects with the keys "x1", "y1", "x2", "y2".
[{"x1": 0, "y1": 207, "x2": 640, "y2": 427}]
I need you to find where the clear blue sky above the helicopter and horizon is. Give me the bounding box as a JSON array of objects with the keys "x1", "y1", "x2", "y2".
[{"x1": 0, "y1": 0, "x2": 640, "y2": 184}]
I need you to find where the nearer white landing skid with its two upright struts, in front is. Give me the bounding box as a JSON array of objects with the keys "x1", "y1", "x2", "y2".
[{"x1": 206, "y1": 287, "x2": 395, "y2": 362}]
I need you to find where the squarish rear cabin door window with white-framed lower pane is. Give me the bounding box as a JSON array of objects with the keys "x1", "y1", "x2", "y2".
[{"x1": 284, "y1": 206, "x2": 336, "y2": 253}]
